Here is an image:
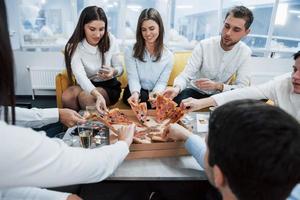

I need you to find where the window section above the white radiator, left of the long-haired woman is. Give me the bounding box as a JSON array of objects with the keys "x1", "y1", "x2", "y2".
[{"x1": 19, "y1": 0, "x2": 76, "y2": 49}]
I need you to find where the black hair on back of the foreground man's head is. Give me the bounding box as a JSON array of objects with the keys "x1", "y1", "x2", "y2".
[{"x1": 207, "y1": 100, "x2": 300, "y2": 200}]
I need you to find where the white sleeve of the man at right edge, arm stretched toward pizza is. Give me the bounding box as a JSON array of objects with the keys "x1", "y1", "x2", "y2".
[{"x1": 211, "y1": 78, "x2": 275, "y2": 106}]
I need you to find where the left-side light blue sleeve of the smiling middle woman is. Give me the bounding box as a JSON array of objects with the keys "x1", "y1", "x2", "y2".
[{"x1": 125, "y1": 48, "x2": 141, "y2": 94}]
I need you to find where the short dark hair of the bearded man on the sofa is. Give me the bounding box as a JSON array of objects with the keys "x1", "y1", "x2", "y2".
[{"x1": 225, "y1": 6, "x2": 254, "y2": 30}]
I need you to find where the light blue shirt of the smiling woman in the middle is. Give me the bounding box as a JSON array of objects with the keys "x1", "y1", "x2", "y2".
[{"x1": 125, "y1": 47, "x2": 173, "y2": 93}]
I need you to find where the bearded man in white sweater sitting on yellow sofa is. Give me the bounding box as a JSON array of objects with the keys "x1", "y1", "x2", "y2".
[{"x1": 163, "y1": 6, "x2": 253, "y2": 104}]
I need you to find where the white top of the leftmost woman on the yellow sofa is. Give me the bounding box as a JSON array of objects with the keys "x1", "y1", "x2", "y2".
[{"x1": 71, "y1": 34, "x2": 123, "y2": 93}]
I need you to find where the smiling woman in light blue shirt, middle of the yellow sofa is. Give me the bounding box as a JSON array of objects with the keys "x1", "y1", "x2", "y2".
[{"x1": 123, "y1": 8, "x2": 173, "y2": 107}]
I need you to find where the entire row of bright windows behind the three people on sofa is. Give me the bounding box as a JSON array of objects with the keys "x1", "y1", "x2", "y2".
[{"x1": 14, "y1": 0, "x2": 300, "y2": 57}]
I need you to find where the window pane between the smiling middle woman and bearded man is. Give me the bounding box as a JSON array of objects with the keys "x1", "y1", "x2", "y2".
[{"x1": 169, "y1": 0, "x2": 220, "y2": 49}]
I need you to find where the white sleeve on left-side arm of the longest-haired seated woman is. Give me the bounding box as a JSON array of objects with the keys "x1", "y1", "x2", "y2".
[{"x1": 71, "y1": 50, "x2": 96, "y2": 94}]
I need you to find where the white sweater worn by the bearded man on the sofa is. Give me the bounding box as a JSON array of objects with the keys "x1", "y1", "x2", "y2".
[{"x1": 174, "y1": 36, "x2": 251, "y2": 91}]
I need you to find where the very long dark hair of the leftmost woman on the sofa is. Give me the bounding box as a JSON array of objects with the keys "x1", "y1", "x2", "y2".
[{"x1": 65, "y1": 6, "x2": 110, "y2": 85}]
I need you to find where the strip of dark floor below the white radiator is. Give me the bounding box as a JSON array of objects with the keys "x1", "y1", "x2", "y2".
[{"x1": 16, "y1": 95, "x2": 56, "y2": 108}]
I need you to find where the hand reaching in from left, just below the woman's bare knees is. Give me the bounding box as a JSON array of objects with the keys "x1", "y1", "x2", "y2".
[{"x1": 58, "y1": 108, "x2": 86, "y2": 127}]
